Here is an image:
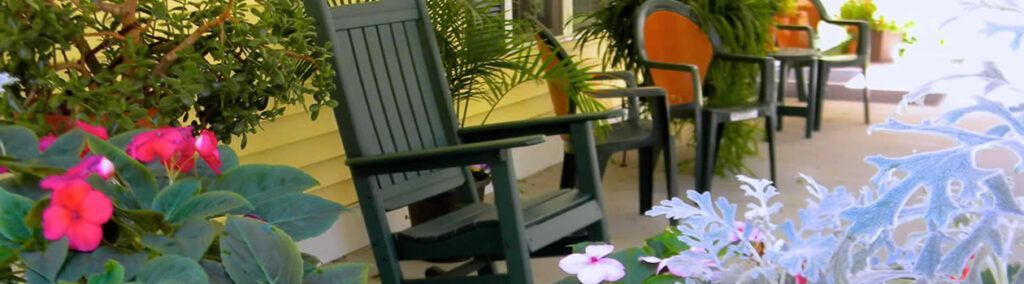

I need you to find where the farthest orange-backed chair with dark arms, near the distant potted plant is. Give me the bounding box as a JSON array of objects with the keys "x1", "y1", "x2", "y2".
[{"x1": 775, "y1": 0, "x2": 871, "y2": 126}]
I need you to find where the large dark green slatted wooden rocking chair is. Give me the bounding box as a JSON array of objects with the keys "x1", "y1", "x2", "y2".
[{"x1": 303, "y1": 0, "x2": 623, "y2": 283}]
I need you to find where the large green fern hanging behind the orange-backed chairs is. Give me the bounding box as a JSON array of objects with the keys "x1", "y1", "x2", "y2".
[{"x1": 578, "y1": 0, "x2": 781, "y2": 175}]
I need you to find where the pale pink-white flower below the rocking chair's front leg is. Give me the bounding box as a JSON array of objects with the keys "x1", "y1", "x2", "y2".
[{"x1": 558, "y1": 242, "x2": 626, "y2": 284}]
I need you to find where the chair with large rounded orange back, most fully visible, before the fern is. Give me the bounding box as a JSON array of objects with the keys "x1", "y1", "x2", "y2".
[{"x1": 633, "y1": 0, "x2": 777, "y2": 191}]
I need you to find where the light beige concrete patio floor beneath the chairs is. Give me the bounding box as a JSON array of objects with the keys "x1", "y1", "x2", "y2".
[{"x1": 342, "y1": 65, "x2": 1021, "y2": 283}]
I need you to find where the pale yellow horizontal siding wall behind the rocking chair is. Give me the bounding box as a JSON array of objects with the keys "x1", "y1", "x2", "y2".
[{"x1": 232, "y1": 41, "x2": 610, "y2": 205}]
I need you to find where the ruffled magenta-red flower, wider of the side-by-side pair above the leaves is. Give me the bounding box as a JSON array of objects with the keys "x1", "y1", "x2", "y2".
[{"x1": 128, "y1": 127, "x2": 196, "y2": 172}]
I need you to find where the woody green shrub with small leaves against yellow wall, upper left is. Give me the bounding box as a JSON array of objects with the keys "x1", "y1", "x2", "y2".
[{"x1": 0, "y1": 0, "x2": 336, "y2": 146}]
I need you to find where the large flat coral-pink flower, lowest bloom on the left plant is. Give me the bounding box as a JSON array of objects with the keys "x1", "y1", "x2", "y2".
[{"x1": 42, "y1": 179, "x2": 114, "y2": 251}]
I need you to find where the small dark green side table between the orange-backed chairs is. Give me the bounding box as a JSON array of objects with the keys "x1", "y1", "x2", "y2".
[{"x1": 768, "y1": 47, "x2": 821, "y2": 138}]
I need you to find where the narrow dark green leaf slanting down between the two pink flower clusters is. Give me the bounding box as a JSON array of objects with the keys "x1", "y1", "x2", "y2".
[{"x1": 86, "y1": 136, "x2": 157, "y2": 204}]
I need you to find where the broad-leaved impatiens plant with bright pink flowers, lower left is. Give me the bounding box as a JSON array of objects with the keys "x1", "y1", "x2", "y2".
[{"x1": 0, "y1": 122, "x2": 368, "y2": 283}]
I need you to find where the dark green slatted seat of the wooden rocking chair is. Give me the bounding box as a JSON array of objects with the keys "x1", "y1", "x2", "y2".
[{"x1": 394, "y1": 186, "x2": 601, "y2": 259}]
